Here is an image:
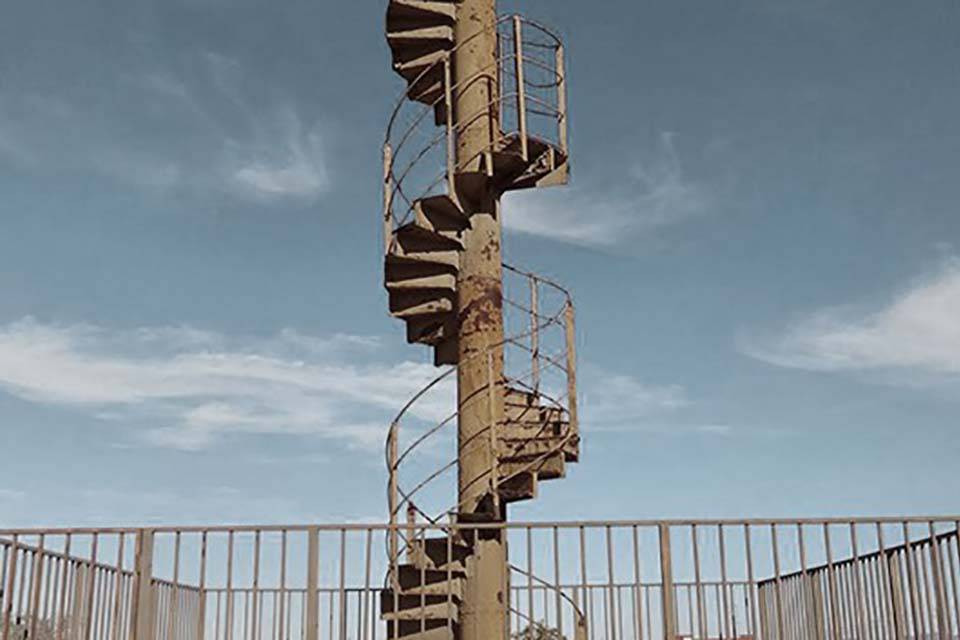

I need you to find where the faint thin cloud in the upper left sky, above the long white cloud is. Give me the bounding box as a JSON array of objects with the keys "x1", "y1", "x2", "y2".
[{"x1": 0, "y1": 52, "x2": 330, "y2": 200}]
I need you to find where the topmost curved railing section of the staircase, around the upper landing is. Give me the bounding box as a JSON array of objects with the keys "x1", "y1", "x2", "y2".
[{"x1": 383, "y1": 15, "x2": 569, "y2": 251}]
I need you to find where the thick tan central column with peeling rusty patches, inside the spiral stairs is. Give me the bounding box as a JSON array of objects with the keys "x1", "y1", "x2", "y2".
[{"x1": 453, "y1": 0, "x2": 509, "y2": 640}]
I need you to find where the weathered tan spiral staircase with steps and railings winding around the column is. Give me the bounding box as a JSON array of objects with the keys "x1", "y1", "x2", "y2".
[{"x1": 381, "y1": 0, "x2": 585, "y2": 640}]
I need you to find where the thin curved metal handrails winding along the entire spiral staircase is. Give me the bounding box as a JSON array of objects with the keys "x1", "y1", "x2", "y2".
[{"x1": 384, "y1": 14, "x2": 584, "y2": 640}]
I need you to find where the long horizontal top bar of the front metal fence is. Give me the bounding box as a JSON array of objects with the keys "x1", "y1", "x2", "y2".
[{"x1": 0, "y1": 514, "x2": 960, "y2": 544}]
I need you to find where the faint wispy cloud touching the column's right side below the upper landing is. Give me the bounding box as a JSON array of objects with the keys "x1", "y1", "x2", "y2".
[{"x1": 504, "y1": 133, "x2": 711, "y2": 247}]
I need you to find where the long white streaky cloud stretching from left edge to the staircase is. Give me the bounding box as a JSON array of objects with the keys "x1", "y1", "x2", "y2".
[{"x1": 0, "y1": 318, "x2": 452, "y2": 449}]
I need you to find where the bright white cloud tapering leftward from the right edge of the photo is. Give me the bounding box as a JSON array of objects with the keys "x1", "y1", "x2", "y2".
[{"x1": 740, "y1": 258, "x2": 960, "y2": 381}]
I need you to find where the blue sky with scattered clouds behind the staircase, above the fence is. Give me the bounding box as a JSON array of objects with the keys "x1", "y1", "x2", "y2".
[{"x1": 0, "y1": 0, "x2": 960, "y2": 525}]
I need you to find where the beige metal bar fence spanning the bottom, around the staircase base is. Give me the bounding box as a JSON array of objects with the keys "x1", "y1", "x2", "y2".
[{"x1": 0, "y1": 517, "x2": 960, "y2": 640}]
